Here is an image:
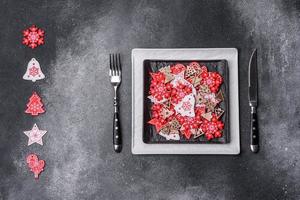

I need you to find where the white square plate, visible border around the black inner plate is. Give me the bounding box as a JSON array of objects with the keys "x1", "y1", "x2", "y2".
[{"x1": 132, "y1": 48, "x2": 240, "y2": 154}]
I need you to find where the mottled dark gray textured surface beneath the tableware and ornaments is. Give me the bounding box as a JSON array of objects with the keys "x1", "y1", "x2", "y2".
[{"x1": 0, "y1": 0, "x2": 300, "y2": 200}]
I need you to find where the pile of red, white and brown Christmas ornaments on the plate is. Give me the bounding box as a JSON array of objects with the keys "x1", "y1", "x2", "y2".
[{"x1": 148, "y1": 62, "x2": 224, "y2": 140}]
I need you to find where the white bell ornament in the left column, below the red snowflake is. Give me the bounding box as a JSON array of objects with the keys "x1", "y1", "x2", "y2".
[{"x1": 23, "y1": 58, "x2": 45, "y2": 82}]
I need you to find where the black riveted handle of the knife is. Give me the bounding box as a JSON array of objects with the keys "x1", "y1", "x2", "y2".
[{"x1": 250, "y1": 107, "x2": 259, "y2": 153}]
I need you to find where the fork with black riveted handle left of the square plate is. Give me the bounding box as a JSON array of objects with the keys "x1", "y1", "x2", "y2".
[{"x1": 109, "y1": 54, "x2": 122, "y2": 153}]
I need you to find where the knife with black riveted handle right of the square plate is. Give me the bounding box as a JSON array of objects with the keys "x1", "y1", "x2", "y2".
[{"x1": 248, "y1": 49, "x2": 259, "y2": 153}]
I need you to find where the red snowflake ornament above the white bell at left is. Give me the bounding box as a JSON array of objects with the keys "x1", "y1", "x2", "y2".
[{"x1": 22, "y1": 25, "x2": 45, "y2": 49}]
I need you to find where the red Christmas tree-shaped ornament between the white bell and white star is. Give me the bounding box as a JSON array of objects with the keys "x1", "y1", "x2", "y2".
[{"x1": 25, "y1": 92, "x2": 45, "y2": 116}]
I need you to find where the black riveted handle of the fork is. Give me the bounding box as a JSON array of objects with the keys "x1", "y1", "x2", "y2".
[{"x1": 113, "y1": 98, "x2": 122, "y2": 153}]
